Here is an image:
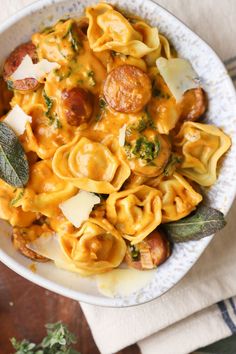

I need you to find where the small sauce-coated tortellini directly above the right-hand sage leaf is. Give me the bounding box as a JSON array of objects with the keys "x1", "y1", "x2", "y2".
[{"x1": 157, "y1": 173, "x2": 202, "y2": 223}]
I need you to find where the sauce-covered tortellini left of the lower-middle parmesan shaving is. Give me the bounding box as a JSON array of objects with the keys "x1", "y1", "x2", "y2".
[{"x1": 17, "y1": 160, "x2": 78, "y2": 217}]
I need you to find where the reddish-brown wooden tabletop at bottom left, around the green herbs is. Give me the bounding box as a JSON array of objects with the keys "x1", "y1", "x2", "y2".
[{"x1": 0, "y1": 263, "x2": 140, "y2": 354}]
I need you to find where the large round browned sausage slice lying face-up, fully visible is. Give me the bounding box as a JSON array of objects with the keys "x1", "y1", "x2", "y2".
[{"x1": 104, "y1": 65, "x2": 151, "y2": 113}]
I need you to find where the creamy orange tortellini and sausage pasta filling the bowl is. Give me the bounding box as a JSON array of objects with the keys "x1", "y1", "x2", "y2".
[{"x1": 0, "y1": 3, "x2": 231, "y2": 276}]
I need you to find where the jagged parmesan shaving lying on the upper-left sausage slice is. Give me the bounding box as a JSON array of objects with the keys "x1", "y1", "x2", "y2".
[{"x1": 11, "y1": 54, "x2": 61, "y2": 81}]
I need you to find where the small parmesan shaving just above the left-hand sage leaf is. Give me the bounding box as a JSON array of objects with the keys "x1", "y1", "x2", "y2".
[{"x1": 4, "y1": 104, "x2": 32, "y2": 136}]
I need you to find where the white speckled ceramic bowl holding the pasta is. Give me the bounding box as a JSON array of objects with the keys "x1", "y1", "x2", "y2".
[{"x1": 0, "y1": 0, "x2": 236, "y2": 307}]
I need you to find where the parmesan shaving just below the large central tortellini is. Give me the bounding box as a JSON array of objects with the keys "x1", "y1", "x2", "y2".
[{"x1": 59, "y1": 190, "x2": 100, "y2": 227}]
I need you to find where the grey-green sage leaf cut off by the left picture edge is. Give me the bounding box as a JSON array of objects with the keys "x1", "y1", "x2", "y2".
[{"x1": 0, "y1": 122, "x2": 29, "y2": 188}]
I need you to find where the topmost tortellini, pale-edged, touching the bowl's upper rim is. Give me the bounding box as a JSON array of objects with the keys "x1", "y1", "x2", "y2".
[{"x1": 86, "y1": 3, "x2": 161, "y2": 58}]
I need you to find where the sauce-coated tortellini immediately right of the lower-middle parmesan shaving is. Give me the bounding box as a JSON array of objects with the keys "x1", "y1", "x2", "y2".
[{"x1": 106, "y1": 185, "x2": 161, "y2": 244}]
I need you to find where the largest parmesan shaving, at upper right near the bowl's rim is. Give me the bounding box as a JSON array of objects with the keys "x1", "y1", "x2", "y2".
[{"x1": 156, "y1": 58, "x2": 200, "y2": 101}]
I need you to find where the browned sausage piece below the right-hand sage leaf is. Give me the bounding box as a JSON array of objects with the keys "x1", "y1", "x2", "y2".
[{"x1": 125, "y1": 230, "x2": 170, "y2": 270}]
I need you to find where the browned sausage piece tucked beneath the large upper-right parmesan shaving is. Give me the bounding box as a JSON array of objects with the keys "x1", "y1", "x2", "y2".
[{"x1": 180, "y1": 88, "x2": 207, "y2": 122}]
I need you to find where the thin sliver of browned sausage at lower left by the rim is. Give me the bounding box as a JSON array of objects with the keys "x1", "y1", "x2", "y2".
[{"x1": 12, "y1": 227, "x2": 49, "y2": 262}]
